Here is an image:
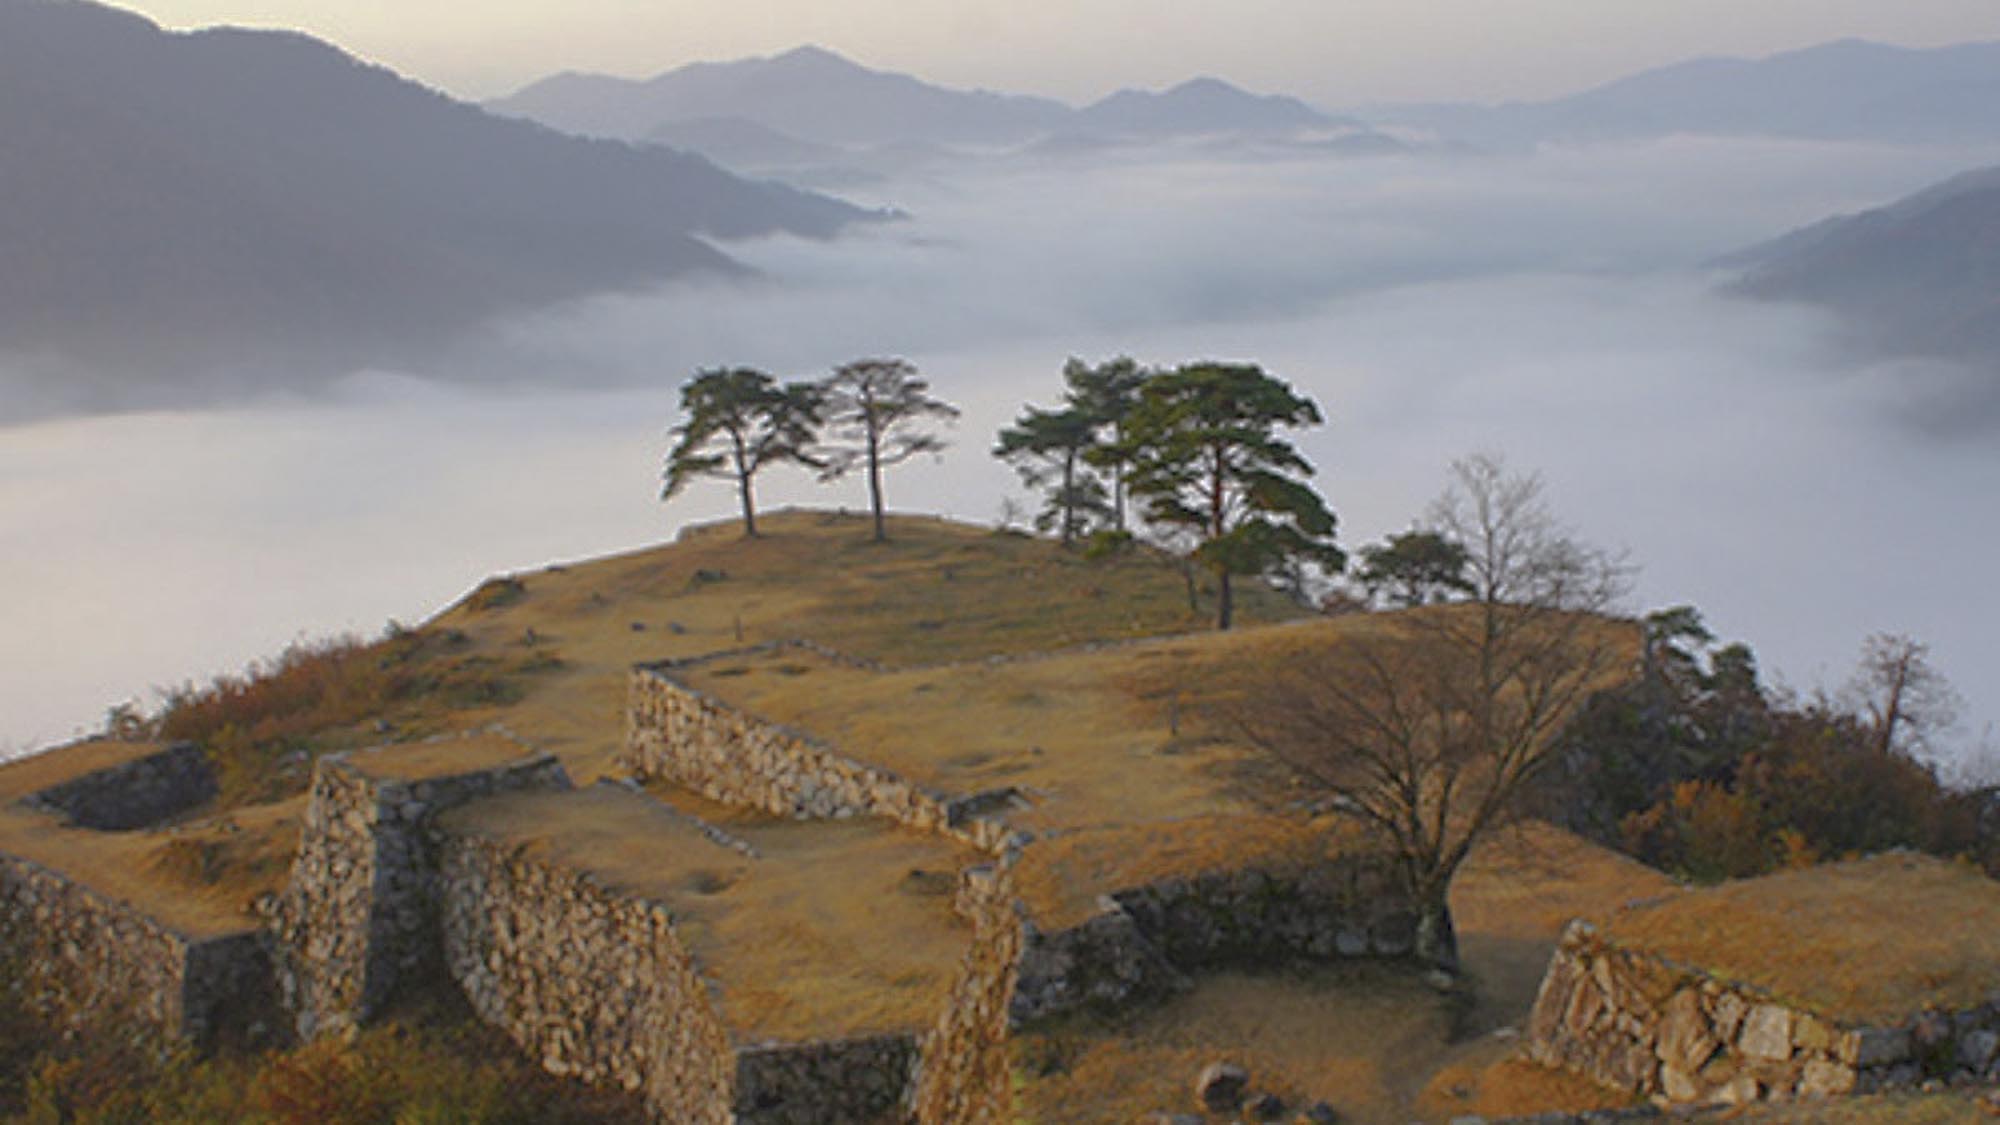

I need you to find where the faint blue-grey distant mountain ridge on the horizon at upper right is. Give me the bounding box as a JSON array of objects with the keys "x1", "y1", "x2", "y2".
[{"x1": 1362, "y1": 40, "x2": 2000, "y2": 146}]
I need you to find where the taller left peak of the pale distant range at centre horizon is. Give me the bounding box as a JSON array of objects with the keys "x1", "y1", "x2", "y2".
[{"x1": 488, "y1": 46, "x2": 1070, "y2": 146}]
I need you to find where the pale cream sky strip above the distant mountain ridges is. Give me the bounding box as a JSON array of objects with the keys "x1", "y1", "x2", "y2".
[{"x1": 130, "y1": 0, "x2": 2000, "y2": 106}]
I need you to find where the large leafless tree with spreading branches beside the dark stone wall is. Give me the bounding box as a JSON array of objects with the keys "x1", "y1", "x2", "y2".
[{"x1": 1222, "y1": 456, "x2": 1638, "y2": 971}]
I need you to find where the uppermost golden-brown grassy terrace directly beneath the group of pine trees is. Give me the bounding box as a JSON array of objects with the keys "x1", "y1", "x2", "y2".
[{"x1": 430, "y1": 510, "x2": 1298, "y2": 783}]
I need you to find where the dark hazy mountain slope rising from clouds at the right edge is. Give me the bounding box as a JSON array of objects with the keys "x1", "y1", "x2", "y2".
[{"x1": 1720, "y1": 168, "x2": 2000, "y2": 370}]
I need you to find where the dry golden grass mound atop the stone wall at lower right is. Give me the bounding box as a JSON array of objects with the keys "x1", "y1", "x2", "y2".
[{"x1": 1606, "y1": 853, "x2": 2000, "y2": 1023}]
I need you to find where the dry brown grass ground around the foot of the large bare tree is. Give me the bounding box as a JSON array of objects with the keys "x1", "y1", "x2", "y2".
[{"x1": 1016, "y1": 825, "x2": 1672, "y2": 1125}]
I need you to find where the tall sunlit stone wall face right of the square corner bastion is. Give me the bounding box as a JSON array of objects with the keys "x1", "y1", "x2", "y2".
[{"x1": 442, "y1": 839, "x2": 738, "y2": 1125}]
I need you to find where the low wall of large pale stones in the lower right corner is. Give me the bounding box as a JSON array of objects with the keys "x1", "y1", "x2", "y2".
[{"x1": 1528, "y1": 923, "x2": 2000, "y2": 1105}]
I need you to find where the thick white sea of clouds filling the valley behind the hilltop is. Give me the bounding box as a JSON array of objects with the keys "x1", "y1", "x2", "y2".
[{"x1": 0, "y1": 129, "x2": 2000, "y2": 755}]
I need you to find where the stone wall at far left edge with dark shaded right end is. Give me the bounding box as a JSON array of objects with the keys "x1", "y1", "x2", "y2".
[{"x1": 0, "y1": 855, "x2": 278, "y2": 1047}]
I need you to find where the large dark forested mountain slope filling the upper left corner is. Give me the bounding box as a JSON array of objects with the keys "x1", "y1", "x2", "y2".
[{"x1": 0, "y1": 0, "x2": 866, "y2": 406}]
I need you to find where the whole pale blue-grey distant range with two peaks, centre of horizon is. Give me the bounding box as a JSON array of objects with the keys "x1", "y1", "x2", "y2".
[{"x1": 490, "y1": 46, "x2": 1342, "y2": 151}]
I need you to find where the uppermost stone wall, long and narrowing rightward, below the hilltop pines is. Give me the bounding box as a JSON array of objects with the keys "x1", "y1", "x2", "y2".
[{"x1": 620, "y1": 657, "x2": 1016, "y2": 851}]
